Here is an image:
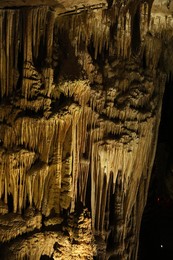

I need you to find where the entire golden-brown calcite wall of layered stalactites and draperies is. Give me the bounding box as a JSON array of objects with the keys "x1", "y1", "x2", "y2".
[{"x1": 0, "y1": 0, "x2": 173, "y2": 260}]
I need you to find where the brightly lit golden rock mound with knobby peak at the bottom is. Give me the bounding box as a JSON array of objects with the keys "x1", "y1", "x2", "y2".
[{"x1": 2, "y1": 210, "x2": 96, "y2": 260}]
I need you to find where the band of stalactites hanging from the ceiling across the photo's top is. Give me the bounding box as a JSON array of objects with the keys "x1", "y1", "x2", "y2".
[{"x1": 0, "y1": 0, "x2": 157, "y2": 98}]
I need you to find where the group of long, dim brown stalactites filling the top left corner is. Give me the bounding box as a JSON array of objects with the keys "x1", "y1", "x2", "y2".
[{"x1": 0, "y1": 7, "x2": 54, "y2": 97}]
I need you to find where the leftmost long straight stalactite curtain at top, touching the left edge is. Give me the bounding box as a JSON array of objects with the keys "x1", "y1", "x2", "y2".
[{"x1": 0, "y1": 10, "x2": 20, "y2": 98}]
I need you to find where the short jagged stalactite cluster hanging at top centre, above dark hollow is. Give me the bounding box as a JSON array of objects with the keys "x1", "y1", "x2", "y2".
[{"x1": 60, "y1": 9, "x2": 109, "y2": 59}]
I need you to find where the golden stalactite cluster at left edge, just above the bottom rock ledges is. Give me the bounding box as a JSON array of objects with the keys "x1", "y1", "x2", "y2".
[{"x1": 0, "y1": 150, "x2": 35, "y2": 213}]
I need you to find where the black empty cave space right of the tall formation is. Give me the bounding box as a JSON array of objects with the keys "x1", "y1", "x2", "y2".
[{"x1": 138, "y1": 77, "x2": 173, "y2": 260}]
